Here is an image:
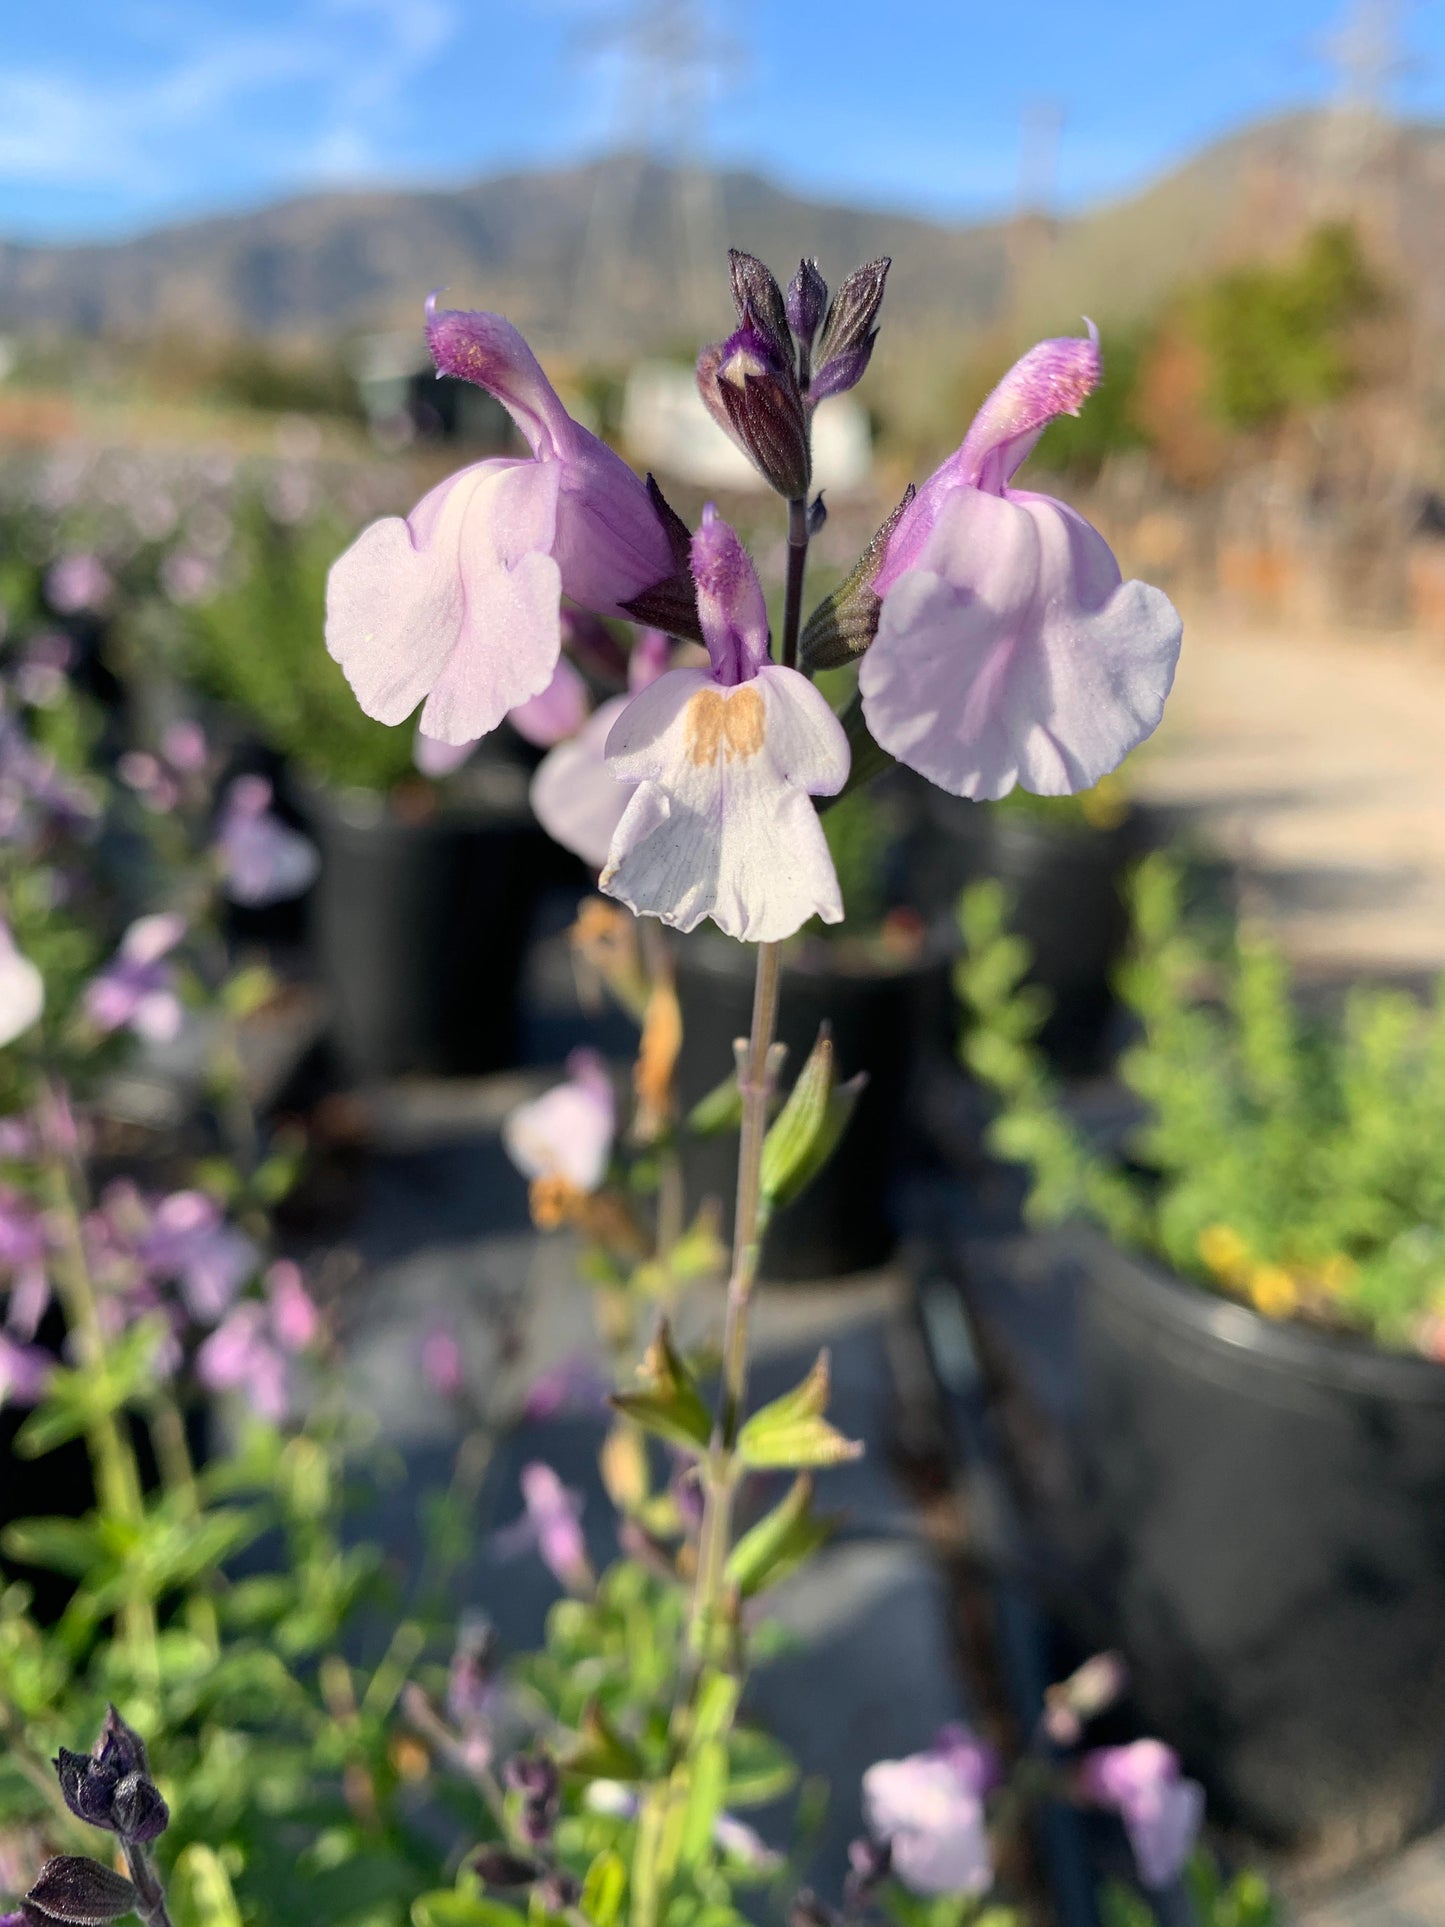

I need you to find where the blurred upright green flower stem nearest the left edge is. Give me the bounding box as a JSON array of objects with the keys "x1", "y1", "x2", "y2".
[{"x1": 44, "y1": 1156, "x2": 160, "y2": 1684}]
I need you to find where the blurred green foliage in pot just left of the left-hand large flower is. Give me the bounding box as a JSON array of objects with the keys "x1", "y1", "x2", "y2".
[{"x1": 187, "y1": 499, "x2": 414, "y2": 790}]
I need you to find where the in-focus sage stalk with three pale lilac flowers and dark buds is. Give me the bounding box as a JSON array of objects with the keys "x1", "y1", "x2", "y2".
[{"x1": 326, "y1": 251, "x2": 1181, "y2": 1927}]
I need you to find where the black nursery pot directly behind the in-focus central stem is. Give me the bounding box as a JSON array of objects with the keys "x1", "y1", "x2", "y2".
[{"x1": 674, "y1": 931, "x2": 948, "y2": 1281}]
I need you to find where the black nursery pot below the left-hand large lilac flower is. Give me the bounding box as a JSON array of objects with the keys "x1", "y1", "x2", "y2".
[{"x1": 310, "y1": 765, "x2": 549, "y2": 1079}]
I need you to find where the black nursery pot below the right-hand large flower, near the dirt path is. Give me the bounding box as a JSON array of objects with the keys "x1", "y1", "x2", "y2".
[{"x1": 907, "y1": 784, "x2": 1146, "y2": 1069}]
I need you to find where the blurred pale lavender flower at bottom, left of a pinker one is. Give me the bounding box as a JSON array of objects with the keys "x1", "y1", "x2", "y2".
[{"x1": 863, "y1": 1725, "x2": 998, "y2": 1894}]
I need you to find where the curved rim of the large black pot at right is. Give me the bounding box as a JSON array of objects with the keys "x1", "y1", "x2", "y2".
[{"x1": 1067, "y1": 1220, "x2": 1445, "y2": 1405}]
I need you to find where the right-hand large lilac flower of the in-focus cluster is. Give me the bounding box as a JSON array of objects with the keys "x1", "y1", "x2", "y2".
[{"x1": 857, "y1": 326, "x2": 1181, "y2": 798}]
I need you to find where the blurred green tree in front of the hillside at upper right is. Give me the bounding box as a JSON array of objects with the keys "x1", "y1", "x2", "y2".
[{"x1": 1193, "y1": 224, "x2": 1379, "y2": 430}]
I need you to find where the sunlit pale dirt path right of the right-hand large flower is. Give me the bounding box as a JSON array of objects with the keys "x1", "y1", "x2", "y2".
[{"x1": 1139, "y1": 611, "x2": 1445, "y2": 979}]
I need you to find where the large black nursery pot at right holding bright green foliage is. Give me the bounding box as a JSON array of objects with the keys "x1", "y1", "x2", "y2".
[{"x1": 1060, "y1": 1233, "x2": 1445, "y2": 1865}]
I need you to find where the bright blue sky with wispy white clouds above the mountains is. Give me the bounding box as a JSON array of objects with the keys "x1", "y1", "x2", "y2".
[{"x1": 0, "y1": 0, "x2": 1445, "y2": 239}]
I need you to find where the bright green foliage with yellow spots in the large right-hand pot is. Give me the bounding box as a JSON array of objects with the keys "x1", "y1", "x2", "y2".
[{"x1": 956, "y1": 858, "x2": 1445, "y2": 1351}]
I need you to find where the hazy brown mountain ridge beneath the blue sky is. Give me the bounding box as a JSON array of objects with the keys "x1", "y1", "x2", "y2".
[{"x1": 0, "y1": 116, "x2": 1445, "y2": 353}]
